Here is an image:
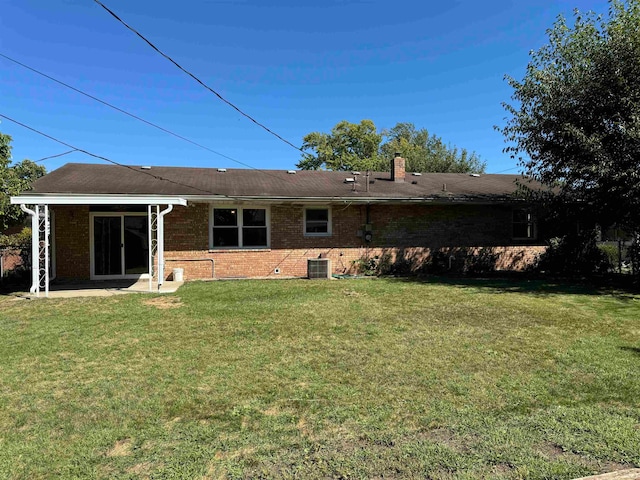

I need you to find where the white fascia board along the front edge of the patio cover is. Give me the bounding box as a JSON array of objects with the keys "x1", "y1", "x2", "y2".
[{"x1": 11, "y1": 194, "x2": 187, "y2": 207}]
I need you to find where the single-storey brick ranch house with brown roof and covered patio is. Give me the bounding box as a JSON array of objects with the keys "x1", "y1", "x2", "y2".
[{"x1": 12, "y1": 157, "x2": 544, "y2": 291}]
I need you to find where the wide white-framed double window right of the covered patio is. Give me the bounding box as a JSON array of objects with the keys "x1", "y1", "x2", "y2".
[{"x1": 210, "y1": 206, "x2": 269, "y2": 248}]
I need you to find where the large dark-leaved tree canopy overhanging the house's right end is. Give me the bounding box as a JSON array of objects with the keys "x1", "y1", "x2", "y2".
[{"x1": 501, "y1": 0, "x2": 640, "y2": 231}]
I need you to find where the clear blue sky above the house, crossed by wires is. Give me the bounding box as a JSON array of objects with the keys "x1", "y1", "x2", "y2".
[{"x1": 0, "y1": 0, "x2": 608, "y2": 173}]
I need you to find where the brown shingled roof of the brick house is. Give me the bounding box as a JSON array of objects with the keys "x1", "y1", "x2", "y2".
[{"x1": 31, "y1": 163, "x2": 540, "y2": 201}]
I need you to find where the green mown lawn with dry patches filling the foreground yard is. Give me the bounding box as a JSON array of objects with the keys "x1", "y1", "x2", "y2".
[{"x1": 0, "y1": 279, "x2": 640, "y2": 479}]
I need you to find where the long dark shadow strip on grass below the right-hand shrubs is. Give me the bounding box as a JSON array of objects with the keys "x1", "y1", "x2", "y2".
[{"x1": 398, "y1": 275, "x2": 640, "y2": 300}]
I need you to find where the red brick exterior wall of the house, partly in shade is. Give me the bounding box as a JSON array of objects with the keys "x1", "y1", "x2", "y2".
[{"x1": 46, "y1": 204, "x2": 544, "y2": 280}]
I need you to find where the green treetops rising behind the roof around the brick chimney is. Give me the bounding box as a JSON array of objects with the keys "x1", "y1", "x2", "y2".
[{"x1": 297, "y1": 120, "x2": 486, "y2": 173}]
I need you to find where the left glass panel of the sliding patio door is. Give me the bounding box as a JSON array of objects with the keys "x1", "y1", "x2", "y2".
[{"x1": 93, "y1": 217, "x2": 122, "y2": 275}]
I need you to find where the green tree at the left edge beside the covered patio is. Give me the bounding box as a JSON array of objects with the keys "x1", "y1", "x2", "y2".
[{"x1": 0, "y1": 133, "x2": 46, "y2": 231}]
